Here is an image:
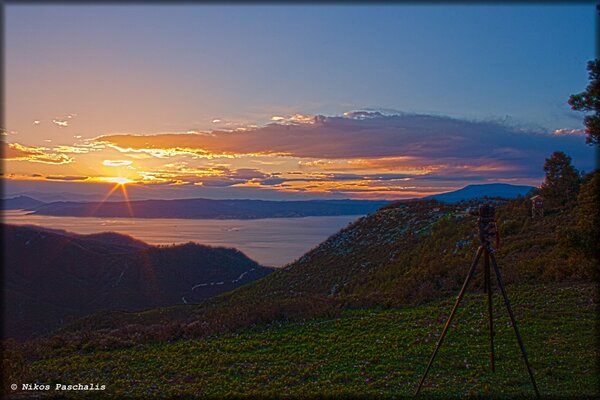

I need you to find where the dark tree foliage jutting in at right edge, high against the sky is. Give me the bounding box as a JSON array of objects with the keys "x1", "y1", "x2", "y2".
[{"x1": 569, "y1": 59, "x2": 600, "y2": 145}]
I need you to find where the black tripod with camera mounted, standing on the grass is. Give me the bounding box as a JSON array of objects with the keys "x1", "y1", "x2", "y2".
[{"x1": 416, "y1": 205, "x2": 540, "y2": 397}]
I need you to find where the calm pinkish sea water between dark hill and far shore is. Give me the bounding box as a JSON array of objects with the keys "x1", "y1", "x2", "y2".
[{"x1": 2, "y1": 210, "x2": 361, "y2": 267}]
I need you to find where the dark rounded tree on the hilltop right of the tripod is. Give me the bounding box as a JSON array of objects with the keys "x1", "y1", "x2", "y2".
[{"x1": 540, "y1": 151, "x2": 581, "y2": 208}]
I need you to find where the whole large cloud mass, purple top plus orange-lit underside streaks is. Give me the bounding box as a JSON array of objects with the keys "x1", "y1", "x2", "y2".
[{"x1": 96, "y1": 111, "x2": 593, "y2": 178}]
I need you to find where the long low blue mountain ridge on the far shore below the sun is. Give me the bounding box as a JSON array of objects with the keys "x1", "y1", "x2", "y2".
[{"x1": 27, "y1": 199, "x2": 390, "y2": 219}]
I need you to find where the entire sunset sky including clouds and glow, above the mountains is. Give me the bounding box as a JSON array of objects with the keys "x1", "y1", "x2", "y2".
[{"x1": 2, "y1": 3, "x2": 596, "y2": 199}]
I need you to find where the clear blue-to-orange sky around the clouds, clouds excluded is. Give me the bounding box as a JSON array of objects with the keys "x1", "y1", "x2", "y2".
[{"x1": 5, "y1": 4, "x2": 595, "y2": 199}]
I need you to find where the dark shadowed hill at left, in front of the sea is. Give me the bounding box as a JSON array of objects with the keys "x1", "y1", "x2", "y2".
[{"x1": 2, "y1": 224, "x2": 272, "y2": 338}]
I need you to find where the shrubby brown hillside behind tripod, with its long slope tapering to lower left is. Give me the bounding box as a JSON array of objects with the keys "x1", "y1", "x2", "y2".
[{"x1": 19, "y1": 191, "x2": 593, "y2": 348}]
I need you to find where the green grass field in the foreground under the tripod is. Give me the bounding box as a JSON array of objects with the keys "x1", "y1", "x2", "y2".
[{"x1": 22, "y1": 284, "x2": 599, "y2": 398}]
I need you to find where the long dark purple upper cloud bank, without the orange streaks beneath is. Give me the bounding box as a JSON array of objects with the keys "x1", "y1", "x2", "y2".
[{"x1": 97, "y1": 112, "x2": 590, "y2": 169}]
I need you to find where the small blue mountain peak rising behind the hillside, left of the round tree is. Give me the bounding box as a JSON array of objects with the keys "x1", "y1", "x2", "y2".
[{"x1": 424, "y1": 183, "x2": 534, "y2": 203}]
